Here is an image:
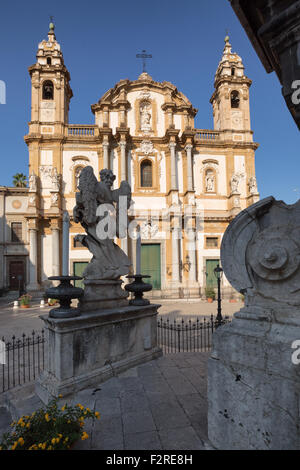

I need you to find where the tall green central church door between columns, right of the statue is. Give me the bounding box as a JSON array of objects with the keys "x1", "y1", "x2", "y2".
[{"x1": 141, "y1": 244, "x2": 161, "y2": 290}]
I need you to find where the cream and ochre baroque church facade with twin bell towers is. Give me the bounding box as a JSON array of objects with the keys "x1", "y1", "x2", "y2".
[{"x1": 0, "y1": 23, "x2": 259, "y2": 297}]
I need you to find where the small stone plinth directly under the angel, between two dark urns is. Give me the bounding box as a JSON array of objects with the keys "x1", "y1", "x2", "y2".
[{"x1": 79, "y1": 280, "x2": 128, "y2": 312}]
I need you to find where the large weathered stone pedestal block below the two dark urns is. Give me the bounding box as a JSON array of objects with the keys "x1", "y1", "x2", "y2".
[{"x1": 36, "y1": 303, "x2": 162, "y2": 403}]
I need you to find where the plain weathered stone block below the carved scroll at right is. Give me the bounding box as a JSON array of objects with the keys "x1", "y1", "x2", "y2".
[{"x1": 207, "y1": 307, "x2": 300, "y2": 450}]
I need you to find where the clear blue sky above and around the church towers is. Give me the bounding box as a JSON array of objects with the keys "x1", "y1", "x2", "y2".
[{"x1": 0, "y1": 0, "x2": 300, "y2": 203}]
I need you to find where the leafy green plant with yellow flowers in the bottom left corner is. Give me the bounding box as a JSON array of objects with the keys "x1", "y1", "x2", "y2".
[{"x1": 0, "y1": 396, "x2": 100, "y2": 450}]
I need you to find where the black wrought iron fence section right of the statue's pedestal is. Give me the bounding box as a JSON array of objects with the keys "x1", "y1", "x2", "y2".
[{"x1": 157, "y1": 315, "x2": 230, "y2": 354}]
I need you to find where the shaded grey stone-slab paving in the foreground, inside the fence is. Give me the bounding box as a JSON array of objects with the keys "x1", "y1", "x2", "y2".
[{"x1": 0, "y1": 353, "x2": 211, "y2": 450}]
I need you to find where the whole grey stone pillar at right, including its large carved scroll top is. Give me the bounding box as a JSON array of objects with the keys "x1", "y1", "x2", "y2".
[{"x1": 207, "y1": 197, "x2": 300, "y2": 450}]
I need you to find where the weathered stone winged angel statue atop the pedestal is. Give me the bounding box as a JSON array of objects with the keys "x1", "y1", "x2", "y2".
[{"x1": 73, "y1": 166, "x2": 131, "y2": 280}]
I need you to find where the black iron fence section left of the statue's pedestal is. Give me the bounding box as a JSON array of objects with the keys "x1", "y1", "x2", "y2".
[{"x1": 0, "y1": 330, "x2": 45, "y2": 392}]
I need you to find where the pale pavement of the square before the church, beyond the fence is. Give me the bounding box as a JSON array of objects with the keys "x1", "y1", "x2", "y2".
[{"x1": 0, "y1": 298, "x2": 243, "y2": 339}]
